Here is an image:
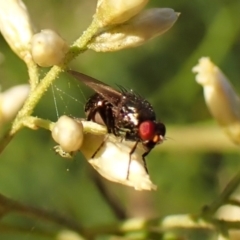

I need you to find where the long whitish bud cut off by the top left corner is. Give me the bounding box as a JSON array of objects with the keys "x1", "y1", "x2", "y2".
[{"x1": 0, "y1": 0, "x2": 33, "y2": 62}]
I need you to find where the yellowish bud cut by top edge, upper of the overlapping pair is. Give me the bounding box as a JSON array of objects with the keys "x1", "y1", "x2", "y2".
[{"x1": 94, "y1": 0, "x2": 148, "y2": 27}]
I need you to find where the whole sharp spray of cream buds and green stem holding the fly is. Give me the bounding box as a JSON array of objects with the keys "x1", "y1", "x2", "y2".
[{"x1": 0, "y1": 0, "x2": 179, "y2": 190}]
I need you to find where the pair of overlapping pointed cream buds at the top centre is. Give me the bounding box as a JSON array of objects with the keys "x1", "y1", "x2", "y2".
[{"x1": 88, "y1": 0, "x2": 179, "y2": 52}]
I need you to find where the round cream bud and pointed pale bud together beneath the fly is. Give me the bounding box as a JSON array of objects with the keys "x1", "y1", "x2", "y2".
[{"x1": 52, "y1": 116, "x2": 156, "y2": 190}]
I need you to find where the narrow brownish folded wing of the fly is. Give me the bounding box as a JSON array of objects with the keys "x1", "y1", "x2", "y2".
[{"x1": 67, "y1": 70, "x2": 122, "y2": 106}]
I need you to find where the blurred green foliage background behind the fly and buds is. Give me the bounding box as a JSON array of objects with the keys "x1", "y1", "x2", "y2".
[{"x1": 0, "y1": 0, "x2": 240, "y2": 240}]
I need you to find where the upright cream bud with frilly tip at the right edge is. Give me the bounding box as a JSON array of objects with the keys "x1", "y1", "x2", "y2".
[{"x1": 193, "y1": 57, "x2": 240, "y2": 144}]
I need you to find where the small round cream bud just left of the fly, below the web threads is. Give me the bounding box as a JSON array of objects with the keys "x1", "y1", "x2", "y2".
[{"x1": 52, "y1": 116, "x2": 83, "y2": 153}]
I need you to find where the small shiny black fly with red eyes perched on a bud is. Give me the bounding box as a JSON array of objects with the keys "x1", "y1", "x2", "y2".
[{"x1": 68, "y1": 70, "x2": 166, "y2": 178}]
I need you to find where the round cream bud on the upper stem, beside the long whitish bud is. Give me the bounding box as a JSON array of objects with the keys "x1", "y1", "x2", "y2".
[{"x1": 31, "y1": 29, "x2": 68, "y2": 67}]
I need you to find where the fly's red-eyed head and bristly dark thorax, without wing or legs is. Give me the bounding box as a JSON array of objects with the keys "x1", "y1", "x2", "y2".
[{"x1": 114, "y1": 91, "x2": 166, "y2": 150}]
